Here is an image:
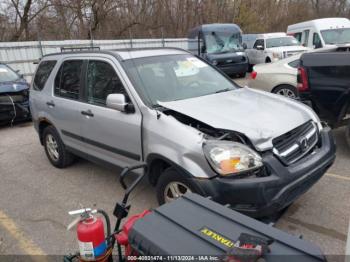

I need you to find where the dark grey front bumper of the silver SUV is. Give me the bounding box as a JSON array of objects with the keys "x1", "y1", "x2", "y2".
[{"x1": 197, "y1": 128, "x2": 336, "y2": 217}]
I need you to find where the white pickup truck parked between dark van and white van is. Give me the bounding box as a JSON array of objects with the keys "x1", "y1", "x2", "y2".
[{"x1": 244, "y1": 33, "x2": 309, "y2": 65}]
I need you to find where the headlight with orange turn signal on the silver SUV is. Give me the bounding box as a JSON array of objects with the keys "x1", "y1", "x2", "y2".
[{"x1": 203, "y1": 140, "x2": 263, "y2": 176}]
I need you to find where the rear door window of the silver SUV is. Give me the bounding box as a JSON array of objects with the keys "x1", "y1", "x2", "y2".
[{"x1": 55, "y1": 60, "x2": 83, "y2": 100}]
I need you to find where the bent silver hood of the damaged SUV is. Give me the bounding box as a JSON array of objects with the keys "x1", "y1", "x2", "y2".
[{"x1": 158, "y1": 87, "x2": 319, "y2": 151}]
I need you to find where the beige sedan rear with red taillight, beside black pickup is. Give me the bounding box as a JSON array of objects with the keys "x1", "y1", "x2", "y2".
[{"x1": 248, "y1": 54, "x2": 301, "y2": 98}]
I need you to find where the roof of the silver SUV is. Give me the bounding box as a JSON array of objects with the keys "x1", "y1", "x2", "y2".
[{"x1": 43, "y1": 47, "x2": 190, "y2": 61}]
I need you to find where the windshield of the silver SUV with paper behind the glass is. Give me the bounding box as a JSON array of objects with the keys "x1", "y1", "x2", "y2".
[{"x1": 123, "y1": 55, "x2": 236, "y2": 106}]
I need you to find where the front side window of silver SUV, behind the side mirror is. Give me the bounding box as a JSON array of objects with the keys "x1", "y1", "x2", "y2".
[{"x1": 86, "y1": 60, "x2": 127, "y2": 106}]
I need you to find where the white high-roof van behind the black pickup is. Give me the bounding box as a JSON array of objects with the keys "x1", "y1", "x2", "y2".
[{"x1": 287, "y1": 17, "x2": 350, "y2": 48}]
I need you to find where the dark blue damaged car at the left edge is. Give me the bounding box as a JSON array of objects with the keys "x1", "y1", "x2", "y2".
[{"x1": 0, "y1": 64, "x2": 30, "y2": 124}]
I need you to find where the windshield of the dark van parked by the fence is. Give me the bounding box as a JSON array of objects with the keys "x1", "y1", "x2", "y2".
[{"x1": 204, "y1": 32, "x2": 243, "y2": 53}]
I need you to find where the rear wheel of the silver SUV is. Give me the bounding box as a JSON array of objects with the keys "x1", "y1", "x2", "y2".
[{"x1": 43, "y1": 126, "x2": 74, "y2": 168}]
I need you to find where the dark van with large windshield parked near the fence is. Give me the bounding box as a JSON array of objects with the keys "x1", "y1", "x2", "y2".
[{"x1": 188, "y1": 24, "x2": 248, "y2": 77}]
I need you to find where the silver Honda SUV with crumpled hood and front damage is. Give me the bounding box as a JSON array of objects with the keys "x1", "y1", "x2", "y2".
[{"x1": 30, "y1": 48, "x2": 335, "y2": 216}]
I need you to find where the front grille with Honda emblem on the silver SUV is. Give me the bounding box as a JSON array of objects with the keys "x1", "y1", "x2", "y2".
[{"x1": 272, "y1": 122, "x2": 318, "y2": 165}]
